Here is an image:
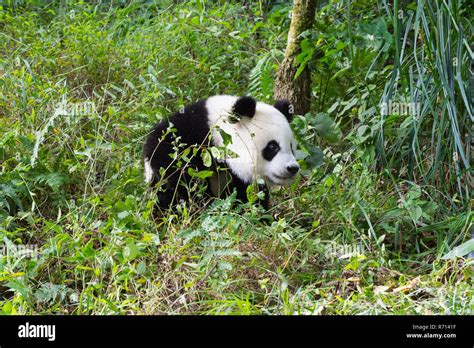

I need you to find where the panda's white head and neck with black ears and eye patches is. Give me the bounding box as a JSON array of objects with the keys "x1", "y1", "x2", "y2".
[{"x1": 207, "y1": 96, "x2": 300, "y2": 185}]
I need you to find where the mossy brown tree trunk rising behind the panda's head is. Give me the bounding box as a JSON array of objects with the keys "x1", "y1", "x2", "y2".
[{"x1": 274, "y1": 0, "x2": 317, "y2": 115}]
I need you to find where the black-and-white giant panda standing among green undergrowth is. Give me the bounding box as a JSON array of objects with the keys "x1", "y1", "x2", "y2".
[{"x1": 143, "y1": 95, "x2": 300, "y2": 210}]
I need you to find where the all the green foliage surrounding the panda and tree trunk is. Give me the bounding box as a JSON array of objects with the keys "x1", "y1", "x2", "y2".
[{"x1": 0, "y1": 0, "x2": 472, "y2": 314}]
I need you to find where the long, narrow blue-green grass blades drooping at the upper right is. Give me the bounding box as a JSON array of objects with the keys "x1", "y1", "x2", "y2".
[{"x1": 377, "y1": 0, "x2": 474, "y2": 208}]
